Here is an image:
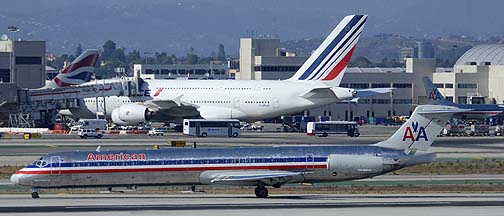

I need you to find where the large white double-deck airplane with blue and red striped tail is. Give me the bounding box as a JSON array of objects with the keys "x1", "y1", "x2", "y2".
[{"x1": 53, "y1": 15, "x2": 391, "y2": 125}]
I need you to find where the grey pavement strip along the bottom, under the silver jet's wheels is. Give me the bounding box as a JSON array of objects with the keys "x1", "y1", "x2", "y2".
[{"x1": 0, "y1": 194, "x2": 504, "y2": 216}]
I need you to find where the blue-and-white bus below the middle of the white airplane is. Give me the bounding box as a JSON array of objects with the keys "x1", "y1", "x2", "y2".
[{"x1": 183, "y1": 119, "x2": 240, "y2": 137}]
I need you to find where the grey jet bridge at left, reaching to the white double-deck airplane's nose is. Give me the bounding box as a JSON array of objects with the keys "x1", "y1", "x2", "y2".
[{"x1": 13, "y1": 80, "x2": 142, "y2": 124}]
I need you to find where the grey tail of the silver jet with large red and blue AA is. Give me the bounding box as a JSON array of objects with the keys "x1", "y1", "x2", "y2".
[{"x1": 376, "y1": 105, "x2": 467, "y2": 153}]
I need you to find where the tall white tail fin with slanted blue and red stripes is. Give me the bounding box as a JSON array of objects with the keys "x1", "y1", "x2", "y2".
[{"x1": 288, "y1": 15, "x2": 367, "y2": 86}]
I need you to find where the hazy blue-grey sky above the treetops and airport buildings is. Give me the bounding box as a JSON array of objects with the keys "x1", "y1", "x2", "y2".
[{"x1": 0, "y1": 0, "x2": 504, "y2": 55}]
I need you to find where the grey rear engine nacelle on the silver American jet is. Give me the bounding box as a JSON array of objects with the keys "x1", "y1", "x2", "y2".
[{"x1": 327, "y1": 154, "x2": 383, "y2": 174}]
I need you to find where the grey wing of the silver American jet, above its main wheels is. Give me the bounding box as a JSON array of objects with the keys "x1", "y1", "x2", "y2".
[{"x1": 200, "y1": 170, "x2": 304, "y2": 186}]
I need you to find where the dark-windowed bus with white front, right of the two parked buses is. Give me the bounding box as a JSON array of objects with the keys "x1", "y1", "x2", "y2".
[{"x1": 306, "y1": 121, "x2": 360, "y2": 137}]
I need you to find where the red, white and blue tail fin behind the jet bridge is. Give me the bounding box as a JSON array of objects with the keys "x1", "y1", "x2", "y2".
[{"x1": 43, "y1": 49, "x2": 100, "y2": 88}]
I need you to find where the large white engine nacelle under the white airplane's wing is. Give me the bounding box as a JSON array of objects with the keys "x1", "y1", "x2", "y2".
[{"x1": 112, "y1": 104, "x2": 152, "y2": 126}]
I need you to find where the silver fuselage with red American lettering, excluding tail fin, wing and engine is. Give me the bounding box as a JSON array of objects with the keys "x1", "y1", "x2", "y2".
[{"x1": 11, "y1": 146, "x2": 435, "y2": 188}]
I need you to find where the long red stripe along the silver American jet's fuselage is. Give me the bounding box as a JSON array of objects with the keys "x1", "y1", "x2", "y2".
[{"x1": 16, "y1": 164, "x2": 327, "y2": 174}]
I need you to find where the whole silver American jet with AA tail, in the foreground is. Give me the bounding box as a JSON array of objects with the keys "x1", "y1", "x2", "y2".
[{"x1": 11, "y1": 105, "x2": 465, "y2": 198}]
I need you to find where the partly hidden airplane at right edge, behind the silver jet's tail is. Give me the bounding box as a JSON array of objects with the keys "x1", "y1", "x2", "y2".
[{"x1": 423, "y1": 76, "x2": 504, "y2": 119}]
